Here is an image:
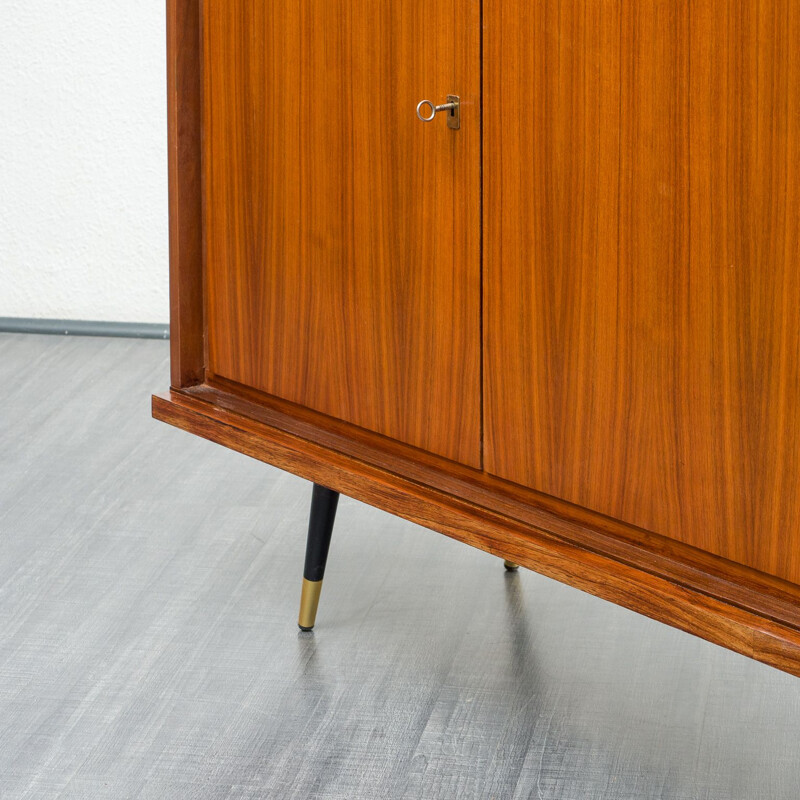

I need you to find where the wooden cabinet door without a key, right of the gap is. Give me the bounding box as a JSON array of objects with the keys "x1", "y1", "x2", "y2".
[{"x1": 484, "y1": 0, "x2": 800, "y2": 582}]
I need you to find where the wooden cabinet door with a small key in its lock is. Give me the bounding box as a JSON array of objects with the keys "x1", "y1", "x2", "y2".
[{"x1": 203, "y1": 0, "x2": 481, "y2": 465}]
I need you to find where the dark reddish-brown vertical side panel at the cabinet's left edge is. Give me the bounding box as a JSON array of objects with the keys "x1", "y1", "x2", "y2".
[{"x1": 167, "y1": 0, "x2": 205, "y2": 387}]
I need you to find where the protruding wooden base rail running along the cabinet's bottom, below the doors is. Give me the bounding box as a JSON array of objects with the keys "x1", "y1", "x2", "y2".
[{"x1": 153, "y1": 384, "x2": 800, "y2": 676}]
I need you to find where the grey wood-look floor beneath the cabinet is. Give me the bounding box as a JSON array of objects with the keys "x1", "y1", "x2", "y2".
[{"x1": 0, "y1": 334, "x2": 800, "y2": 800}]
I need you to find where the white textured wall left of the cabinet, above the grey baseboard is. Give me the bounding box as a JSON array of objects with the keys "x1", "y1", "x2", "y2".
[{"x1": 0, "y1": 0, "x2": 169, "y2": 322}]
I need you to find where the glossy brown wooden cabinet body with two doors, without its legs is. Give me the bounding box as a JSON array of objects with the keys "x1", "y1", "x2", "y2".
[{"x1": 153, "y1": 0, "x2": 800, "y2": 674}]
